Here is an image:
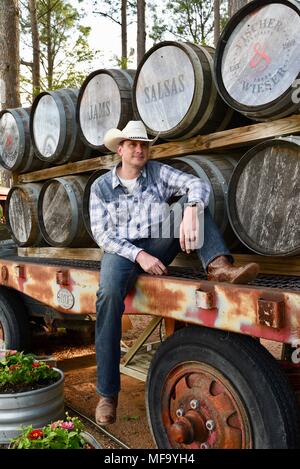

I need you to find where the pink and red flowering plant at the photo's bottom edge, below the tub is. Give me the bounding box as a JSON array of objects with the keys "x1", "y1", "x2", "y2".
[{"x1": 10, "y1": 414, "x2": 93, "y2": 449}]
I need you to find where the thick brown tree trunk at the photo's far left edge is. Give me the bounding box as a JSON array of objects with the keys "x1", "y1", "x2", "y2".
[{"x1": 0, "y1": 0, "x2": 21, "y2": 109}]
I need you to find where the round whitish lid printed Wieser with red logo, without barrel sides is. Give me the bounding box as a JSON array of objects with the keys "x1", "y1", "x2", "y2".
[{"x1": 222, "y1": 4, "x2": 300, "y2": 106}]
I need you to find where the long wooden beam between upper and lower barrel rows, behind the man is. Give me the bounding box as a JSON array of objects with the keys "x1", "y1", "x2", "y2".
[{"x1": 17, "y1": 115, "x2": 300, "y2": 183}]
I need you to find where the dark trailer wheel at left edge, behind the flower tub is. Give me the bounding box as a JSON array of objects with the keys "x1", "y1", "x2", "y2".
[{"x1": 0, "y1": 287, "x2": 30, "y2": 351}]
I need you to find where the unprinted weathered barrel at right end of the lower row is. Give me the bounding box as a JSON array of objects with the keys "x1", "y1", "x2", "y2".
[{"x1": 228, "y1": 137, "x2": 300, "y2": 256}]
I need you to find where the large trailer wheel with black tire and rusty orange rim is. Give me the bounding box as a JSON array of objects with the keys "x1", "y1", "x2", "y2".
[{"x1": 146, "y1": 327, "x2": 299, "y2": 449}]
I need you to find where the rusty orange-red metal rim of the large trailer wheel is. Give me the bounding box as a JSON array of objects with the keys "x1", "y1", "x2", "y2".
[{"x1": 162, "y1": 362, "x2": 252, "y2": 449}]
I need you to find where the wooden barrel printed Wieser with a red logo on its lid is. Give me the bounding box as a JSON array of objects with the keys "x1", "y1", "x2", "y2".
[{"x1": 215, "y1": 0, "x2": 300, "y2": 121}]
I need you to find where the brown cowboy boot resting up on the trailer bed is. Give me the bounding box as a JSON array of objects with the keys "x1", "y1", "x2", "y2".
[{"x1": 207, "y1": 256, "x2": 259, "y2": 283}]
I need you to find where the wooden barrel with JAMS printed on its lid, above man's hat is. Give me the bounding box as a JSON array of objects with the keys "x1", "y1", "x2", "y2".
[{"x1": 77, "y1": 69, "x2": 135, "y2": 151}]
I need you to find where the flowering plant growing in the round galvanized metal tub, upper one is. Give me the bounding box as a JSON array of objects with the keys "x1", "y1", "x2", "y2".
[{"x1": 0, "y1": 352, "x2": 60, "y2": 394}]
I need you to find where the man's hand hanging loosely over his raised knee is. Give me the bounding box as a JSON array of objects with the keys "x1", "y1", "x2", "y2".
[{"x1": 179, "y1": 206, "x2": 199, "y2": 254}]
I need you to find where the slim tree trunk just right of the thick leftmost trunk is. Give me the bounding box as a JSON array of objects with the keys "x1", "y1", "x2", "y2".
[{"x1": 28, "y1": 0, "x2": 41, "y2": 98}]
